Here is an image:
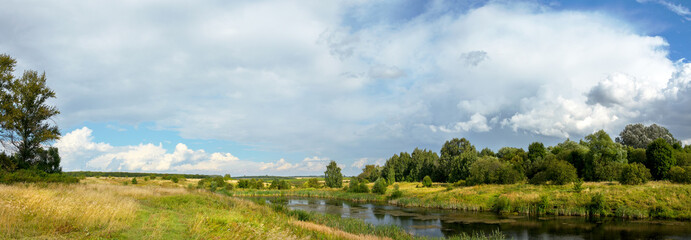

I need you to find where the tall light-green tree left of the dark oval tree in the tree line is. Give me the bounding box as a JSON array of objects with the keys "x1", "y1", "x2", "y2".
[{"x1": 584, "y1": 130, "x2": 627, "y2": 181}]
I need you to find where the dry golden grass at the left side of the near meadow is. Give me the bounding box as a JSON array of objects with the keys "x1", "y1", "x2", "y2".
[{"x1": 0, "y1": 184, "x2": 185, "y2": 238}]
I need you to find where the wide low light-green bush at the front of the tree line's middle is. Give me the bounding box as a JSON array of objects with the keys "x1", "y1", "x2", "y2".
[{"x1": 466, "y1": 157, "x2": 523, "y2": 185}]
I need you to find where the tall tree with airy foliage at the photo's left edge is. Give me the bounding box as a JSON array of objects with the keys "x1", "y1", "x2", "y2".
[{"x1": 0, "y1": 55, "x2": 60, "y2": 169}]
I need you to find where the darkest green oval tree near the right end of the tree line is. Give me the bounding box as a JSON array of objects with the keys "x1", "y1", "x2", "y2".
[{"x1": 645, "y1": 138, "x2": 676, "y2": 180}]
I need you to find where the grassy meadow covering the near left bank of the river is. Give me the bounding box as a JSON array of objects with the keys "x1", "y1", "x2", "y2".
[{"x1": 0, "y1": 177, "x2": 503, "y2": 239}]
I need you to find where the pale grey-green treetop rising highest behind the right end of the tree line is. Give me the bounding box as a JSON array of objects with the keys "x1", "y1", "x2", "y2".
[{"x1": 616, "y1": 123, "x2": 679, "y2": 148}]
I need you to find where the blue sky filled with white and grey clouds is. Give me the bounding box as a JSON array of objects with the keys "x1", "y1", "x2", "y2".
[{"x1": 0, "y1": 0, "x2": 691, "y2": 176}]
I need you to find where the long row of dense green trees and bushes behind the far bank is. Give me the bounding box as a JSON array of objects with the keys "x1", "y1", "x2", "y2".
[{"x1": 357, "y1": 124, "x2": 691, "y2": 188}]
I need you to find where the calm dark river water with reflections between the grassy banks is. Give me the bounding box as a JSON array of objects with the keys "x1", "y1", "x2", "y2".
[{"x1": 255, "y1": 198, "x2": 691, "y2": 239}]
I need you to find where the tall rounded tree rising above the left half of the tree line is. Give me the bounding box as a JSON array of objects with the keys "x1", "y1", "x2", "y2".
[{"x1": 439, "y1": 138, "x2": 478, "y2": 182}]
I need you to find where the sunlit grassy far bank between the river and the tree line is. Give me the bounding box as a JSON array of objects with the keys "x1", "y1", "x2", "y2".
[{"x1": 227, "y1": 181, "x2": 691, "y2": 220}]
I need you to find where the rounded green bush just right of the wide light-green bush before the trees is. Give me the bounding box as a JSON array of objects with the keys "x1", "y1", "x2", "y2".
[{"x1": 530, "y1": 160, "x2": 578, "y2": 185}]
